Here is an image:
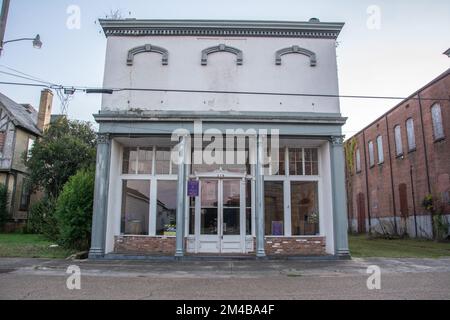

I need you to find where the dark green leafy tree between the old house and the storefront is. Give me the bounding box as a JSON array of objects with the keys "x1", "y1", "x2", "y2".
[{"x1": 25, "y1": 118, "x2": 96, "y2": 199}]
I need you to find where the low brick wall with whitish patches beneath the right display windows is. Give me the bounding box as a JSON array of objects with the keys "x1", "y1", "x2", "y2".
[{"x1": 265, "y1": 237, "x2": 326, "y2": 256}]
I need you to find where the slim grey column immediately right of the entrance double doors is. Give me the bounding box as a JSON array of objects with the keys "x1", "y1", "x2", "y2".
[{"x1": 255, "y1": 135, "x2": 266, "y2": 258}]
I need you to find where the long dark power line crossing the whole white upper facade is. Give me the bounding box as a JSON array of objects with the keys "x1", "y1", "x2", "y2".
[{"x1": 0, "y1": 79, "x2": 450, "y2": 101}]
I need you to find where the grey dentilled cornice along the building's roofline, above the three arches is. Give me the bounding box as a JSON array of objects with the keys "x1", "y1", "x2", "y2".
[{"x1": 99, "y1": 19, "x2": 344, "y2": 39}]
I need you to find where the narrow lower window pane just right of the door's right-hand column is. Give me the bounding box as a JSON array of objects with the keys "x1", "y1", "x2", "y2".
[{"x1": 264, "y1": 181, "x2": 284, "y2": 236}]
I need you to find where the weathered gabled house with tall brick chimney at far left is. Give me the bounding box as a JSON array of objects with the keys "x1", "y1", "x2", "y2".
[{"x1": 0, "y1": 90, "x2": 53, "y2": 229}]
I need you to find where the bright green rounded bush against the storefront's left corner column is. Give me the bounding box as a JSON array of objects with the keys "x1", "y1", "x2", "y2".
[{"x1": 55, "y1": 169, "x2": 95, "y2": 250}]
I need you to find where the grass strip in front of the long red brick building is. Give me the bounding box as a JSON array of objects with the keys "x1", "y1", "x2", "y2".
[{"x1": 349, "y1": 235, "x2": 450, "y2": 259}]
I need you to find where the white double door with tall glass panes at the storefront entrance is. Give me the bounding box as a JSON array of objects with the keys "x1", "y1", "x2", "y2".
[{"x1": 196, "y1": 179, "x2": 246, "y2": 253}]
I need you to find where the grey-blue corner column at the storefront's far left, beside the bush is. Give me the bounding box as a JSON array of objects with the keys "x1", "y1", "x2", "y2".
[{"x1": 89, "y1": 134, "x2": 111, "y2": 259}]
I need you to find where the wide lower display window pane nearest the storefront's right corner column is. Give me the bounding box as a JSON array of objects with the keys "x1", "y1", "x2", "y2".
[{"x1": 291, "y1": 181, "x2": 319, "y2": 236}]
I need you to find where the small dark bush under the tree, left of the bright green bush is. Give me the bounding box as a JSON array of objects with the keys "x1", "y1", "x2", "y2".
[{"x1": 27, "y1": 197, "x2": 59, "y2": 241}]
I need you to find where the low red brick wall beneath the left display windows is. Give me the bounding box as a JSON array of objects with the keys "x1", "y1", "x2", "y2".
[{"x1": 114, "y1": 236, "x2": 176, "y2": 255}]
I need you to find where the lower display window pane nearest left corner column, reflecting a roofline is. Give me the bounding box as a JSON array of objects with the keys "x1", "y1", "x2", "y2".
[{"x1": 121, "y1": 180, "x2": 150, "y2": 235}]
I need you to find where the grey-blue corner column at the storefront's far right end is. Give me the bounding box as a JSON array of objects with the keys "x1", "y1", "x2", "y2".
[{"x1": 330, "y1": 136, "x2": 350, "y2": 258}]
